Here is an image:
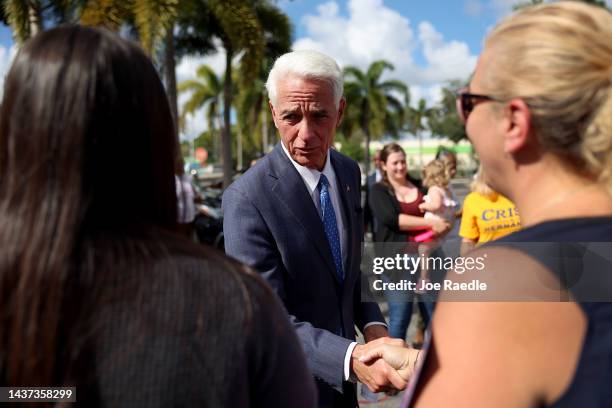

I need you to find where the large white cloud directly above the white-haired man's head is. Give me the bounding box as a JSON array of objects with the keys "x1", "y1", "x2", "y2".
[{"x1": 293, "y1": 0, "x2": 476, "y2": 108}]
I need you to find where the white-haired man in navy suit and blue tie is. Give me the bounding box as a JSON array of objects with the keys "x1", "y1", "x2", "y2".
[{"x1": 223, "y1": 51, "x2": 405, "y2": 407}]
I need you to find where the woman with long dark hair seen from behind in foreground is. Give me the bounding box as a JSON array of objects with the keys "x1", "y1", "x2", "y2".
[{"x1": 0, "y1": 27, "x2": 316, "y2": 407}]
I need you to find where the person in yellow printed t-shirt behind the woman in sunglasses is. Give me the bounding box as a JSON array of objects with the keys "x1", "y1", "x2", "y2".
[{"x1": 459, "y1": 166, "x2": 521, "y2": 256}]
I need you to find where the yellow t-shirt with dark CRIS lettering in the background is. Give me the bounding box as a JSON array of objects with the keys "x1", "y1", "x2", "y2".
[{"x1": 459, "y1": 193, "x2": 521, "y2": 244}]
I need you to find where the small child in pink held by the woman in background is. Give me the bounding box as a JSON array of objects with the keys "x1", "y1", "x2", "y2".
[{"x1": 415, "y1": 160, "x2": 457, "y2": 293}]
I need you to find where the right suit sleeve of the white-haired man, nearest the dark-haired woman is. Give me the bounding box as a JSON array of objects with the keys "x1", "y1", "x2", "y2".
[{"x1": 222, "y1": 186, "x2": 351, "y2": 392}]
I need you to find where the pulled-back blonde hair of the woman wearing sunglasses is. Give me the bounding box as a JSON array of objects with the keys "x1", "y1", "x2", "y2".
[{"x1": 483, "y1": 1, "x2": 612, "y2": 192}]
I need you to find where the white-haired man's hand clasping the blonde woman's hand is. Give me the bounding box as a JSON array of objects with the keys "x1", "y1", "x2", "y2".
[{"x1": 351, "y1": 338, "x2": 406, "y2": 392}]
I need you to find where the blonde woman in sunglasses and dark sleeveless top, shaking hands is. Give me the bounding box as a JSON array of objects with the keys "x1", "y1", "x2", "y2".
[{"x1": 358, "y1": 1, "x2": 612, "y2": 407}]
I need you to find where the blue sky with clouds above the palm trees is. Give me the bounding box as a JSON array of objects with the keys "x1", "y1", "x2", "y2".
[{"x1": 0, "y1": 0, "x2": 612, "y2": 139}]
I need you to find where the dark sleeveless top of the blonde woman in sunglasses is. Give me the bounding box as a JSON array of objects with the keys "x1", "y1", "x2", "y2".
[{"x1": 491, "y1": 217, "x2": 612, "y2": 408}]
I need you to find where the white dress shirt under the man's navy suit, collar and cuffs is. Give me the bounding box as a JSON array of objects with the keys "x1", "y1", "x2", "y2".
[{"x1": 281, "y1": 146, "x2": 387, "y2": 381}]
